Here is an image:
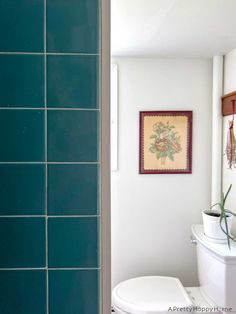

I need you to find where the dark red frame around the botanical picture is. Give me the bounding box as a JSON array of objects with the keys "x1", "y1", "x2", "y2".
[{"x1": 139, "y1": 110, "x2": 193, "y2": 174}]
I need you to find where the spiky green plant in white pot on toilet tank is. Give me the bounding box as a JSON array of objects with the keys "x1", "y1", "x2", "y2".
[{"x1": 202, "y1": 184, "x2": 236, "y2": 249}]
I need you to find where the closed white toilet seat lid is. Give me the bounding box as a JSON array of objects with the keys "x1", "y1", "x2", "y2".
[{"x1": 112, "y1": 276, "x2": 193, "y2": 314}]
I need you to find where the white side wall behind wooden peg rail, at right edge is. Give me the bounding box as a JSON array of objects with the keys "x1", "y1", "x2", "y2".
[{"x1": 222, "y1": 49, "x2": 236, "y2": 235}]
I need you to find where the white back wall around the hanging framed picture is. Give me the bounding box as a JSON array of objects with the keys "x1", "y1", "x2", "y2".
[{"x1": 112, "y1": 58, "x2": 212, "y2": 286}]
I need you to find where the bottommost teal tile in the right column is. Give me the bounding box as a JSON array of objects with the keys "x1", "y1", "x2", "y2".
[{"x1": 49, "y1": 270, "x2": 99, "y2": 314}]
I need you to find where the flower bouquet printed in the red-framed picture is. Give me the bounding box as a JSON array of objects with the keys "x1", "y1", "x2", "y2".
[{"x1": 149, "y1": 121, "x2": 182, "y2": 164}]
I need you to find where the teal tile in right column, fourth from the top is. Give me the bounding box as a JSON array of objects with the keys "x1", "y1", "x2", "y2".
[{"x1": 48, "y1": 165, "x2": 99, "y2": 215}]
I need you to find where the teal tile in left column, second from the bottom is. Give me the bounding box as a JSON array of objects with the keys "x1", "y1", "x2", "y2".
[{"x1": 0, "y1": 217, "x2": 46, "y2": 268}]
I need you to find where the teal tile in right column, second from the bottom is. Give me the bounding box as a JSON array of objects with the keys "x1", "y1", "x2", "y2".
[{"x1": 48, "y1": 217, "x2": 98, "y2": 268}]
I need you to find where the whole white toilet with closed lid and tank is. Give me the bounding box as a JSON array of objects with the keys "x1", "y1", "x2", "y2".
[{"x1": 112, "y1": 225, "x2": 236, "y2": 314}]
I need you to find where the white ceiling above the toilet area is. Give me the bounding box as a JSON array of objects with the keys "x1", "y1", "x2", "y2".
[{"x1": 111, "y1": 0, "x2": 236, "y2": 57}]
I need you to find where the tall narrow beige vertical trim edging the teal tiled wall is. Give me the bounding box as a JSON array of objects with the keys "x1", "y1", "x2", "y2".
[{"x1": 100, "y1": 0, "x2": 111, "y2": 314}]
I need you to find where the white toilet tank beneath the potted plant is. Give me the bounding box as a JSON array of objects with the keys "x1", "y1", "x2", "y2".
[{"x1": 192, "y1": 225, "x2": 236, "y2": 313}]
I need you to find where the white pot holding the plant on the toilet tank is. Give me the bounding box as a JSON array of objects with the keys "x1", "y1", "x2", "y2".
[{"x1": 202, "y1": 210, "x2": 233, "y2": 242}]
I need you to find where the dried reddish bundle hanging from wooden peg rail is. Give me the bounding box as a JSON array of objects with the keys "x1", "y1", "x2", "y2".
[{"x1": 225, "y1": 100, "x2": 236, "y2": 169}]
